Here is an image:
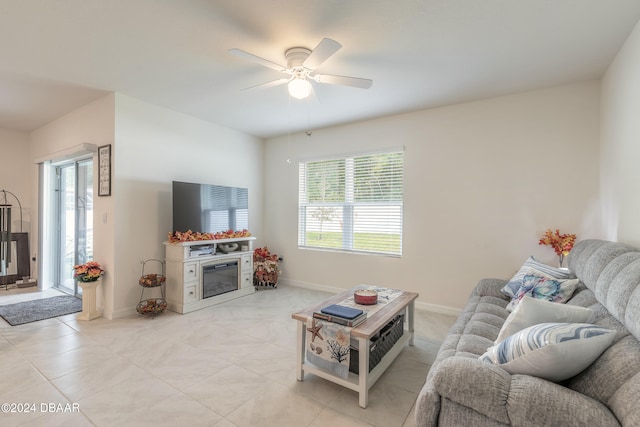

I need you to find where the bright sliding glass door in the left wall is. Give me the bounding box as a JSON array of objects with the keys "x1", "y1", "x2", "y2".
[{"x1": 52, "y1": 159, "x2": 93, "y2": 295}]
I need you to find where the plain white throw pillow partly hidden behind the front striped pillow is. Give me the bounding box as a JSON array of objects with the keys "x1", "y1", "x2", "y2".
[{"x1": 495, "y1": 295, "x2": 594, "y2": 344}]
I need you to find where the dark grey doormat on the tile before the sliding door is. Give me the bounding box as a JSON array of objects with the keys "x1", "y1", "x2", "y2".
[{"x1": 0, "y1": 295, "x2": 82, "y2": 326}]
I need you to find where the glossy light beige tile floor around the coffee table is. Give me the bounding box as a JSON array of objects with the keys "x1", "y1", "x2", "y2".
[{"x1": 0, "y1": 286, "x2": 455, "y2": 427}]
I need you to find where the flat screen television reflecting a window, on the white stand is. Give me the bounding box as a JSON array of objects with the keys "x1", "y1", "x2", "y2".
[{"x1": 173, "y1": 181, "x2": 249, "y2": 233}]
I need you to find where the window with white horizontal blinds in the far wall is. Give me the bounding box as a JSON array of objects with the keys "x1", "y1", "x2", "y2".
[{"x1": 298, "y1": 150, "x2": 404, "y2": 256}]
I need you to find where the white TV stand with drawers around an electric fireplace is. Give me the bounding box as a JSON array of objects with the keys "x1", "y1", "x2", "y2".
[{"x1": 164, "y1": 237, "x2": 256, "y2": 314}]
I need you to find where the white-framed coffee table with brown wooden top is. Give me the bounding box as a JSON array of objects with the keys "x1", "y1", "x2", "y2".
[{"x1": 291, "y1": 285, "x2": 418, "y2": 408}]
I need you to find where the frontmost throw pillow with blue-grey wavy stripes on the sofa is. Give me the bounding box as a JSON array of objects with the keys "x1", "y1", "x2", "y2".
[{"x1": 480, "y1": 323, "x2": 615, "y2": 381}]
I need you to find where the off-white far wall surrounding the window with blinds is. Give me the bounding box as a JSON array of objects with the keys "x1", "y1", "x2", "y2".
[{"x1": 264, "y1": 81, "x2": 602, "y2": 312}]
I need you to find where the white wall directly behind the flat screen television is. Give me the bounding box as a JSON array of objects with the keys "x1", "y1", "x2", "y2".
[{"x1": 112, "y1": 94, "x2": 264, "y2": 317}]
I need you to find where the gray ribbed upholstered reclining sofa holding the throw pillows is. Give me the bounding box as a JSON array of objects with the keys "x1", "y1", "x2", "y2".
[{"x1": 415, "y1": 240, "x2": 640, "y2": 427}]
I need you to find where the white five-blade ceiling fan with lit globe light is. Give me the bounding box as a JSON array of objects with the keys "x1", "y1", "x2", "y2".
[{"x1": 229, "y1": 37, "x2": 373, "y2": 99}]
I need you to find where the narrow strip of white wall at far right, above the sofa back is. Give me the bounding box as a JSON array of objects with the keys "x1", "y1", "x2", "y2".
[{"x1": 601, "y1": 23, "x2": 640, "y2": 246}]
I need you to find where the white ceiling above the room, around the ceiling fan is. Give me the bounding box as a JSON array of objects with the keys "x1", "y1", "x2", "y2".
[{"x1": 0, "y1": 0, "x2": 640, "y2": 137}]
